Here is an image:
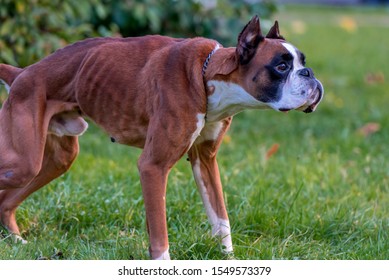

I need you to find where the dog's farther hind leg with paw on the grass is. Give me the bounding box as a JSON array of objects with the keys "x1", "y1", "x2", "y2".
[{"x1": 0, "y1": 134, "x2": 79, "y2": 243}]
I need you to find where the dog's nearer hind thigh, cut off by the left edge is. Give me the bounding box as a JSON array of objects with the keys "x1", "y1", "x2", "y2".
[{"x1": 0, "y1": 76, "x2": 50, "y2": 189}]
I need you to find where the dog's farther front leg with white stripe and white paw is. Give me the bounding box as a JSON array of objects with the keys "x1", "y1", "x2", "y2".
[{"x1": 188, "y1": 118, "x2": 233, "y2": 253}]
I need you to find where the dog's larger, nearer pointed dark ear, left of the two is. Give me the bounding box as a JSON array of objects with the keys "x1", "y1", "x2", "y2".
[{"x1": 236, "y1": 16, "x2": 264, "y2": 65}]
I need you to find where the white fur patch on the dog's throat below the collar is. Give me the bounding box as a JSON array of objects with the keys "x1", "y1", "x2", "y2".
[{"x1": 207, "y1": 80, "x2": 267, "y2": 122}]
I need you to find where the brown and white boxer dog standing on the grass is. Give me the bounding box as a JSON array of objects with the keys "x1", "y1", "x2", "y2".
[{"x1": 0, "y1": 17, "x2": 323, "y2": 259}]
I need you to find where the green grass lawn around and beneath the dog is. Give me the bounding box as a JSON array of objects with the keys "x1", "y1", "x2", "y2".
[{"x1": 0, "y1": 7, "x2": 389, "y2": 259}]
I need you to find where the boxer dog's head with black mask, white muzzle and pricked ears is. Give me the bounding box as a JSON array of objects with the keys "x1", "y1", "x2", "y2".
[{"x1": 236, "y1": 16, "x2": 324, "y2": 113}]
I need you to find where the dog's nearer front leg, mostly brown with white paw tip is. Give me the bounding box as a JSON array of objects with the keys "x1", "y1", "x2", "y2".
[{"x1": 138, "y1": 114, "x2": 204, "y2": 259}]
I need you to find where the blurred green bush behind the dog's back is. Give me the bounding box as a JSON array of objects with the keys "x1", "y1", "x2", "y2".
[{"x1": 0, "y1": 0, "x2": 275, "y2": 67}]
